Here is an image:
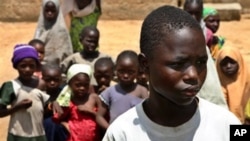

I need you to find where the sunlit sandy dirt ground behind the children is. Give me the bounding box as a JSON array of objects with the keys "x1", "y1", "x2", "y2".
[{"x1": 0, "y1": 15, "x2": 250, "y2": 141}]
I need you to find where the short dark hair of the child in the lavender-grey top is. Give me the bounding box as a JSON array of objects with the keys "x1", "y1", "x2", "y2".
[{"x1": 116, "y1": 50, "x2": 139, "y2": 65}]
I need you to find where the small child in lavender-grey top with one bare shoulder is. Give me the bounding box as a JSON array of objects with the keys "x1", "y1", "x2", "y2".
[{"x1": 97, "y1": 50, "x2": 148, "y2": 129}]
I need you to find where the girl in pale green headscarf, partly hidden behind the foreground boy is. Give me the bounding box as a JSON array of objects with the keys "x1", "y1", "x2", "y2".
[{"x1": 203, "y1": 7, "x2": 225, "y2": 60}]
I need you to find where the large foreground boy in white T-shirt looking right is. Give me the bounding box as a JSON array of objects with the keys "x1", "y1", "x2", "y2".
[{"x1": 103, "y1": 6, "x2": 240, "y2": 141}]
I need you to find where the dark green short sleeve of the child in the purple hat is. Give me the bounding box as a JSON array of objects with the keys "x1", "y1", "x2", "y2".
[{"x1": 0, "y1": 81, "x2": 16, "y2": 105}]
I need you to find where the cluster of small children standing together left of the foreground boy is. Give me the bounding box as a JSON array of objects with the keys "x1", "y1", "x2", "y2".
[{"x1": 0, "y1": 42, "x2": 148, "y2": 141}]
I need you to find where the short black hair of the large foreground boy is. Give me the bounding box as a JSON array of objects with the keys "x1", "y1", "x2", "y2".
[{"x1": 140, "y1": 6, "x2": 202, "y2": 58}]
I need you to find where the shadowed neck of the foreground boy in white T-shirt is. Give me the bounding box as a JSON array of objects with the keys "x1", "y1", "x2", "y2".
[{"x1": 143, "y1": 91, "x2": 199, "y2": 127}]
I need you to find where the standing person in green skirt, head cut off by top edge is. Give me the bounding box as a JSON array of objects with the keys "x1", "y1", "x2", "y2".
[{"x1": 62, "y1": 0, "x2": 101, "y2": 52}]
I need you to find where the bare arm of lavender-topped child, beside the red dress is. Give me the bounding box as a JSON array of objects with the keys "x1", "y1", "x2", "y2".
[{"x1": 96, "y1": 97, "x2": 109, "y2": 129}]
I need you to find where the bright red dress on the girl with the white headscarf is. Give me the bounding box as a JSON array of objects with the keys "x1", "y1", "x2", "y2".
[{"x1": 53, "y1": 102, "x2": 100, "y2": 141}]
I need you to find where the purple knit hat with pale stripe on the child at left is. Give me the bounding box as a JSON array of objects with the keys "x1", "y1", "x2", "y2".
[{"x1": 11, "y1": 44, "x2": 40, "y2": 68}]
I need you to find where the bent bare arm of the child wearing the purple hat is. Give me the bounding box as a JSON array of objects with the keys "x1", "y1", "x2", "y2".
[{"x1": 0, "y1": 99, "x2": 32, "y2": 117}]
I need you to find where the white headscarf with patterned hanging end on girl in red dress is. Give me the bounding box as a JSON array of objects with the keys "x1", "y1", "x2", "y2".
[{"x1": 56, "y1": 64, "x2": 92, "y2": 107}]
